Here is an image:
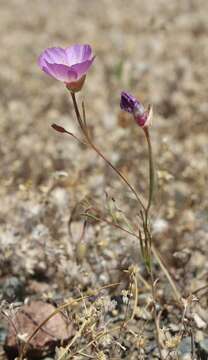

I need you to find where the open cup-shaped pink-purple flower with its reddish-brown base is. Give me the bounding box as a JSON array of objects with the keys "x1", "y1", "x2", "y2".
[{"x1": 38, "y1": 44, "x2": 95, "y2": 91}]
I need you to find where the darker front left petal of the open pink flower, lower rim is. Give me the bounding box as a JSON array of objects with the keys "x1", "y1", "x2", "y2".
[{"x1": 42, "y1": 61, "x2": 77, "y2": 83}]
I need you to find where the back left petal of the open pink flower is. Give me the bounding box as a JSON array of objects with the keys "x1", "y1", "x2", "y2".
[{"x1": 38, "y1": 47, "x2": 67, "y2": 68}]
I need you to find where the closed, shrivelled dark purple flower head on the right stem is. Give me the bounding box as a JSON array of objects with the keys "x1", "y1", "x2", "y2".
[{"x1": 120, "y1": 91, "x2": 150, "y2": 127}]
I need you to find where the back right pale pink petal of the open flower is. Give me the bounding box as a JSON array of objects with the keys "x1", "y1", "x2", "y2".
[{"x1": 65, "y1": 44, "x2": 92, "y2": 65}]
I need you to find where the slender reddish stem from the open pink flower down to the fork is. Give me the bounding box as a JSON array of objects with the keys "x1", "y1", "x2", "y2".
[{"x1": 71, "y1": 92, "x2": 145, "y2": 211}]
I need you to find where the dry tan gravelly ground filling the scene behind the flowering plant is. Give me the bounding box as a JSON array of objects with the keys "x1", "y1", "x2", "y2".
[{"x1": 0, "y1": 0, "x2": 208, "y2": 360}]
